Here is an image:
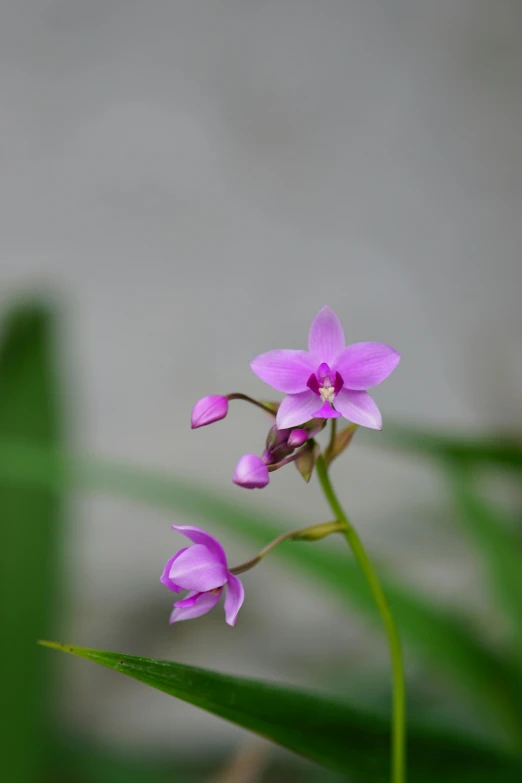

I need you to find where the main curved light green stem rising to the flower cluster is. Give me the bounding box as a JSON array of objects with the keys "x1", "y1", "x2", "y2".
[{"x1": 316, "y1": 455, "x2": 406, "y2": 783}]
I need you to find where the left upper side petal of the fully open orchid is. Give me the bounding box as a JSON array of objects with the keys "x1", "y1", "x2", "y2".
[{"x1": 250, "y1": 352, "x2": 312, "y2": 394}]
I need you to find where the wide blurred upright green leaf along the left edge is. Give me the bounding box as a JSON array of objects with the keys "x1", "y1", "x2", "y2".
[{"x1": 0, "y1": 306, "x2": 61, "y2": 783}]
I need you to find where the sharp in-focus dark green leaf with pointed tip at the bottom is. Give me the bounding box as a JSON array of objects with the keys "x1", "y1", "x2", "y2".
[{"x1": 41, "y1": 642, "x2": 522, "y2": 783}]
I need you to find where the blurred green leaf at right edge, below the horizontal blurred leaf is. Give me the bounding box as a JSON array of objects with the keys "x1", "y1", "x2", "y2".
[{"x1": 450, "y1": 478, "x2": 522, "y2": 656}]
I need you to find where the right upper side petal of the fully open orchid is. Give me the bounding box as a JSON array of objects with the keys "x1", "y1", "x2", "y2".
[{"x1": 336, "y1": 343, "x2": 401, "y2": 391}]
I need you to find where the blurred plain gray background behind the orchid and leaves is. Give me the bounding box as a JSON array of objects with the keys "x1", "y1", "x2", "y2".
[{"x1": 0, "y1": 0, "x2": 522, "y2": 760}]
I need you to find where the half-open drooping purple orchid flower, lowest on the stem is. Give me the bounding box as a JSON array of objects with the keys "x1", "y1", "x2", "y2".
[{"x1": 160, "y1": 525, "x2": 245, "y2": 626}]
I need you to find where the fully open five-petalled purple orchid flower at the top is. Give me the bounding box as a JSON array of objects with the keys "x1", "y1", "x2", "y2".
[{"x1": 250, "y1": 307, "x2": 401, "y2": 430}]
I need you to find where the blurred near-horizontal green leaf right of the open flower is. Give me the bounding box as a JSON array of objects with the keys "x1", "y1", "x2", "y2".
[{"x1": 374, "y1": 422, "x2": 522, "y2": 471}]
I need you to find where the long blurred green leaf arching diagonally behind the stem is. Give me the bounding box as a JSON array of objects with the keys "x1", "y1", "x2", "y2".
[{"x1": 0, "y1": 443, "x2": 522, "y2": 744}]
